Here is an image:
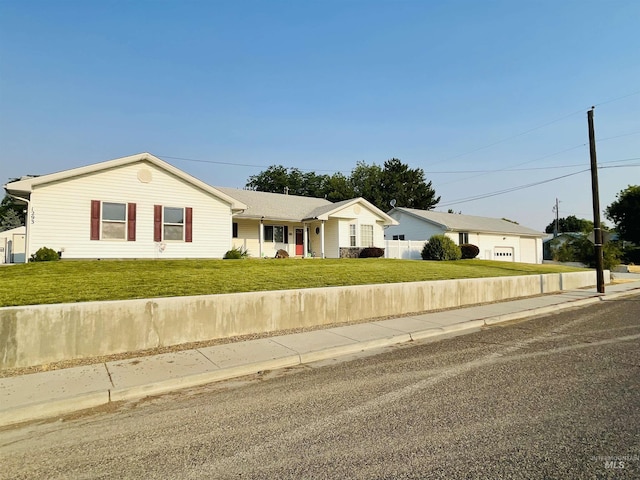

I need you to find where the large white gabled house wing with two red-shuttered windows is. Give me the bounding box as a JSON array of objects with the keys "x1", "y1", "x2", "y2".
[{"x1": 5, "y1": 153, "x2": 246, "y2": 258}]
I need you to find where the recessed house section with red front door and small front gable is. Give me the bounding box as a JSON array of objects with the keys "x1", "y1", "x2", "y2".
[{"x1": 216, "y1": 187, "x2": 397, "y2": 258}]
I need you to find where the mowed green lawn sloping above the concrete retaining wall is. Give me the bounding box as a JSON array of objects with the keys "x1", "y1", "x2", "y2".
[{"x1": 0, "y1": 258, "x2": 580, "y2": 307}]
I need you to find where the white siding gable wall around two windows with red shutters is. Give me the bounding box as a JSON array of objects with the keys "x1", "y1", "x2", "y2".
[{"x1": 27, "y1": 162, "x2": 231, "y2": 258}]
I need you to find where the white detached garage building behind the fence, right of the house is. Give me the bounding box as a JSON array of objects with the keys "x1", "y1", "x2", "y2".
[{"x1": 385, "y1": 207, "x2": 546, "y2": 263}]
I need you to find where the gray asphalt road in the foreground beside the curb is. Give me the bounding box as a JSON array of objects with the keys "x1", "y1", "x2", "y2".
[{"x1": 0, "y1": 295, "x2": 640, "y2": 479}]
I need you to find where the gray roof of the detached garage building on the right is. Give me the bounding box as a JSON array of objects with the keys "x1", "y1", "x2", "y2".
[{"x1": 396, "y1": 208, "x2": 546, "y2": 237}]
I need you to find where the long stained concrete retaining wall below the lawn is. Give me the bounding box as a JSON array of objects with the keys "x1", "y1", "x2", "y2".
[{"x1": 0, "y1": 271, "x2": 610, "y2": 369}]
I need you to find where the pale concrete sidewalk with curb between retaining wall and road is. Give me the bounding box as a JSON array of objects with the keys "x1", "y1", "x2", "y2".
[{"x1": 0, "y1": 275, "x2": 640, "y2": 426}]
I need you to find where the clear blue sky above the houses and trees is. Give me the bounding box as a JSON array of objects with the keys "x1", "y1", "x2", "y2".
[{"x1": 0, "y1": 0, "x2": 640, "y2": 230}]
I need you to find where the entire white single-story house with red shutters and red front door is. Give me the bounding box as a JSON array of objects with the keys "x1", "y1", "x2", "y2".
[{"x1": 4, "y1": 153, "x2": 397, "y2": 261}]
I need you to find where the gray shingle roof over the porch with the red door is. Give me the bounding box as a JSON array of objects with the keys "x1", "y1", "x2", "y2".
[{"x1": 215, "y1": 187, "x2": 336, "y2": 222}]
